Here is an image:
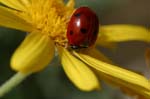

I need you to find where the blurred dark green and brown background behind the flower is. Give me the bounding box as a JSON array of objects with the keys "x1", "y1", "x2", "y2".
[{"x1": 0, "y1": 0, "x2": 150, "y2": 99}]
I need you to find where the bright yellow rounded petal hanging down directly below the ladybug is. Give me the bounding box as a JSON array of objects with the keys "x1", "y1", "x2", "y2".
[{"x1": 59, "y1": 48, "x2": 99, "y2": 91}]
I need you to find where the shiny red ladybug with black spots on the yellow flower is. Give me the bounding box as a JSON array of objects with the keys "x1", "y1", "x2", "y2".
[{"x1": 67, "y1": 7, "x2": 99, "y2": 49}]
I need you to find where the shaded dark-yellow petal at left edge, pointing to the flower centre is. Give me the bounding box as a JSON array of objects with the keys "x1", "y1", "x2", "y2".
[{"x1": 0, "y1": 7, "x2": 33, "y2": 31}]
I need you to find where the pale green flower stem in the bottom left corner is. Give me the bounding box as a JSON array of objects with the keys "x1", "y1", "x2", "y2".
[{"x1": 0, "y1": 72, "x2": 31, "y2": 98}]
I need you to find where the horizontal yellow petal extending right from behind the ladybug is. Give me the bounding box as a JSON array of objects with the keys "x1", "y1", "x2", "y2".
[{"x1": 98, "y1": 24, "x2": 150, "y2": 42}]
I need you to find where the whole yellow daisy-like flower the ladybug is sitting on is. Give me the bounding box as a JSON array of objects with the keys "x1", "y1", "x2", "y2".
[{"x1": 0, "y1": 0, "x2": 150, "y2": 99}]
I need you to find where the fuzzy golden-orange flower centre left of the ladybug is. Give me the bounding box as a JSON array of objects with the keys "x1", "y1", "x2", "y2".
[{"x1": 21, "y1": 0, "x2": 74, "y2": 46}]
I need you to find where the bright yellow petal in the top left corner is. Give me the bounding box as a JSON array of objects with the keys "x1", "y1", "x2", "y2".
[{"x1": 0, "y1": 0, "x2": 29, "y2": 11}]
